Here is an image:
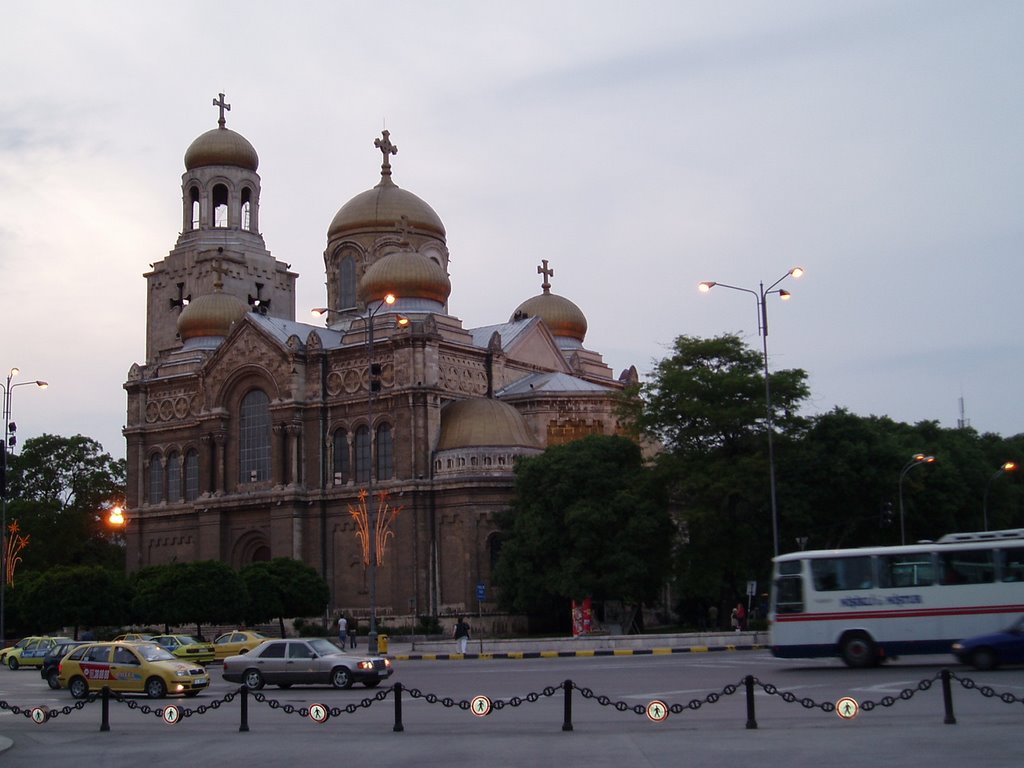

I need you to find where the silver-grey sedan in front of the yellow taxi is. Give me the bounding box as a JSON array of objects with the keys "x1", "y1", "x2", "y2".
[{"x1": 223, "y1": 637, "x2": 394, "y2": 690}]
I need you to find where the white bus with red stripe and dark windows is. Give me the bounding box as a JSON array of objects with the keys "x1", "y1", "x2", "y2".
[{"x1": 769, "y1": 528, "x2": 1024, "y2": 667}]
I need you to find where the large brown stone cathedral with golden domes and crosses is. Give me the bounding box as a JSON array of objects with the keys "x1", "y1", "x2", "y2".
[{"x1": 124, "y1": 94, "x2": 637, "y2": 615}]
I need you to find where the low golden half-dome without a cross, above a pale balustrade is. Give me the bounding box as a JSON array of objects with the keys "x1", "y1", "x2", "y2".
[{"x1": 437, "y1": 397, "x2": 539, "y2": 451}]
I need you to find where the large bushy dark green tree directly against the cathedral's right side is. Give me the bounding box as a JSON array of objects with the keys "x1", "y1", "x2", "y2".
[{"x1": 494, "y1": 436, "x2": 673, "y2": 626}]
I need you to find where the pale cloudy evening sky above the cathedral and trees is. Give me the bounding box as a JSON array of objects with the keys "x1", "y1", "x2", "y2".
[{"x1": 0, "y1": 0, "x2": 1024, "y2": 457}]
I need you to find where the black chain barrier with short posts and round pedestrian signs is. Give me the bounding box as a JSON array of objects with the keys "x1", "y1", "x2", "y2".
[{"x1": 0, "y1": 670, "x2": 1024, "y2": 731}]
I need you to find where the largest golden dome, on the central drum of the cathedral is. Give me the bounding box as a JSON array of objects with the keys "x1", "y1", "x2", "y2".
[{"x1": 327, "y1": 176, "x2": 444, "y2": 240}]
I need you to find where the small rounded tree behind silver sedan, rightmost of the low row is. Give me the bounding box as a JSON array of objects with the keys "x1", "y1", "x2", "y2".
[{"x1": 242, "y1": 557, "x2": 331, "y2": 637}]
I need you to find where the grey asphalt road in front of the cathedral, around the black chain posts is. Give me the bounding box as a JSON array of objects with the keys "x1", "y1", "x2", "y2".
[{"x1": 0, "y1": 651, "x2": 1024, "y2": 768}]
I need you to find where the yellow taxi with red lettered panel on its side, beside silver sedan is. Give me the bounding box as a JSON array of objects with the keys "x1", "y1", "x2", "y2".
[{"x1": 57, "y1": 642, "x2": 210, "y2": 698}]
